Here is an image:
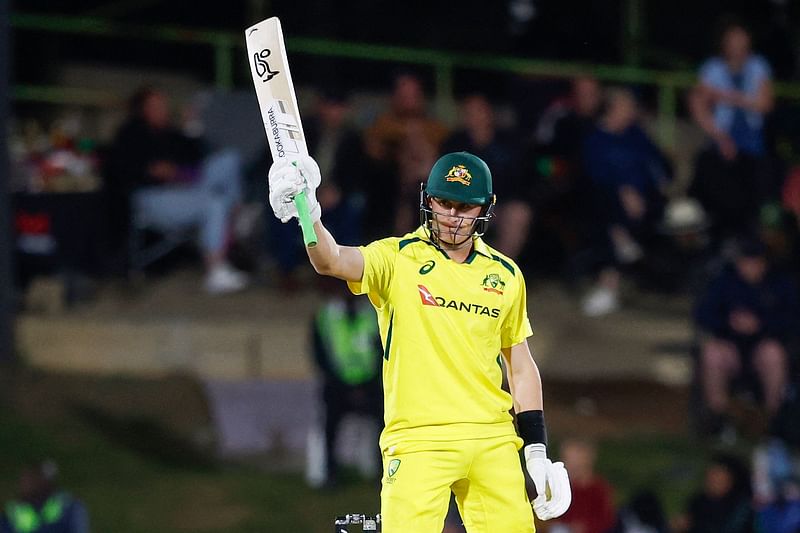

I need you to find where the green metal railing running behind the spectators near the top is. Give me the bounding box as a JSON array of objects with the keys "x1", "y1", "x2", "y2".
[{"x1": 11, "y1": 13, "x2": 800, "y2": 148}]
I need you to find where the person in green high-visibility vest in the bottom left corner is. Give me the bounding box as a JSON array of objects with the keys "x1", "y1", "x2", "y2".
[{"x1": 0, "y1": 461, "x2": 89, "y2": 533}]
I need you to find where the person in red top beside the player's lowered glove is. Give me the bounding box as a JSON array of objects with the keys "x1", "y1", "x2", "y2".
[{"x1": 551, "y1": 439, "x2": 615, "y2": 533}]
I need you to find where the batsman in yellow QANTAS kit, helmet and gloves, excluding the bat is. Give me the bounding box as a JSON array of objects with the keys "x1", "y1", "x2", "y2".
[{"x1": 269, "y1": 152, "x2": 571, "y2": 533}]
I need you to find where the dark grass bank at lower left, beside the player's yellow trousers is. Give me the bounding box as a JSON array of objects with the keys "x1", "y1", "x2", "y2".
[{"x1": 0, "y1": 409, "x2": 379, "y2": 533}]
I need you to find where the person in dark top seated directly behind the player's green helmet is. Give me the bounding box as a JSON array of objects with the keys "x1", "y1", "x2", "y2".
[{"x1": 442, "y1": 94, "x2": 533, "y2": 259}]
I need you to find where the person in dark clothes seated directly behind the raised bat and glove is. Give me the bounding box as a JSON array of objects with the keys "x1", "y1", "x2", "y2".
[{"x1": 268, "y1": 88, "x2": 365, "y2": 291}]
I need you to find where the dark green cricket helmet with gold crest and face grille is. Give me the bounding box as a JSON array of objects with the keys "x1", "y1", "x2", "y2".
[{"x1": 419, "y1": 152, "x2": 495, "y2": 237}]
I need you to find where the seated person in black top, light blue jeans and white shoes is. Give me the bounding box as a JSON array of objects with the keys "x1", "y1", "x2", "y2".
[{"x1": 108, "y1": 87, "x2": 247, "y2": 294}]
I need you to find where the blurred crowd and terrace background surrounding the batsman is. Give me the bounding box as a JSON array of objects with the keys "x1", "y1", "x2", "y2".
[{"x1": 0, "y1": 0, "x2": 800, "y2": 533}]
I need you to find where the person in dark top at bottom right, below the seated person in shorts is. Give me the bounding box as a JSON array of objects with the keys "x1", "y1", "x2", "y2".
[{"x1": 673, "y1": 455, "x2": 753, "y2": 533}]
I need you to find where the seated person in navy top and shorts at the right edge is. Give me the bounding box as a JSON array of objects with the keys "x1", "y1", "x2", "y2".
[{"x1": 695, "y1": 239, "x2": 798, "y2": 431}]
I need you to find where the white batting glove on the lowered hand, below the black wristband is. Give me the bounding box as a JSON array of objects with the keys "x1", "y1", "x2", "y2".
[{"x1": 523, "y1": 444, "x2": 572, "y2": 520}]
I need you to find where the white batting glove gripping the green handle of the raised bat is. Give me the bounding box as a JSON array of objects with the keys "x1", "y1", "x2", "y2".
[{"x1": 269, "y1": 156, "x2": 322, "y2": 222}]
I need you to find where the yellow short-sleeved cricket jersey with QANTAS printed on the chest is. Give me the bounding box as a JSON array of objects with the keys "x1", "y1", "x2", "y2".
[{"x1": 349, "y1": 227, "x2": 532, "y2": 449}]
